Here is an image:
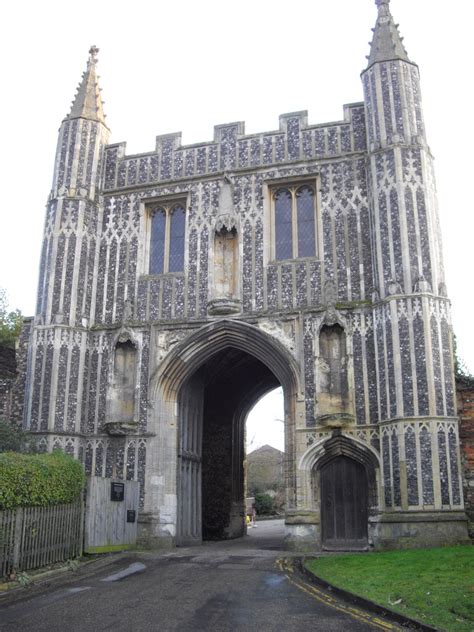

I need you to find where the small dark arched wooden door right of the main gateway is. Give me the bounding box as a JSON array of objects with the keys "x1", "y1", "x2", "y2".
[{"x1": 320, "y1": 456, "x2": 368, "y2": 550}]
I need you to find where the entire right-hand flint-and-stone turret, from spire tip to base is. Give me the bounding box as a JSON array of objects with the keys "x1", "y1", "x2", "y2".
[{"x1": 362, "y1": 0, "x2": 461, "y2": 524}]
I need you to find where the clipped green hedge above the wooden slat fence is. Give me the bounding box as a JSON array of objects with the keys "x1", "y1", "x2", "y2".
[{"x1": 0, "y1": 451, "x2": 85, "y2": 509}]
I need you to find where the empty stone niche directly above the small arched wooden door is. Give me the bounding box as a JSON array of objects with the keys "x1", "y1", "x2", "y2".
[{"x1": 318, "y1": 324, "x2": 350, "y2": 415}]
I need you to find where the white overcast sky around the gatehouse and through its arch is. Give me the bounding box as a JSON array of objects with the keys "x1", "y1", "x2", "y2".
[{"x1": 0, "y1": 0, "x2": 474, "y2": 454}]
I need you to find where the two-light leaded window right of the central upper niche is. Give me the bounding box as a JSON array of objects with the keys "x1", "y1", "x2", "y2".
[{"x1": 273, "y1": 184, "x2": 316, "y2": 260}]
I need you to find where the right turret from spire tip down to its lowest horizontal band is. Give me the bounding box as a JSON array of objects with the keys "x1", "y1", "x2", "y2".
[{"x1": 362, "y1": 0, "x2": 454, "y2": 420}]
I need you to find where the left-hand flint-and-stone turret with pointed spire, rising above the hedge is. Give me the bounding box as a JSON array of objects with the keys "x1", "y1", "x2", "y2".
[{"x1": 25, "y1": 46, "x2": 109, "y2": 436}]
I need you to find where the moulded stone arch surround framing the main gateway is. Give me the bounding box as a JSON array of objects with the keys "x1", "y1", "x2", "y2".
[{"x1": 142, "y1": 319, "x2": 301, "y2": 546}]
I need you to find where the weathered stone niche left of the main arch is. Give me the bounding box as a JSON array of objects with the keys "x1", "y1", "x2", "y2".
[{"x1": 106, "y1": 339, "x2": 137, "y2": 435}]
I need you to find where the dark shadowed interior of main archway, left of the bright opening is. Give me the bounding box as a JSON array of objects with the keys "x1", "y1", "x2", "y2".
[{"x1": 177, "y1": 346, "x2": 280, "y2": 545}]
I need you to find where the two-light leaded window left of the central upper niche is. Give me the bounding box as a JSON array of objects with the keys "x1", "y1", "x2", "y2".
[{"x1": 149, "y1": 201, "x2": 186, "y2": 274}]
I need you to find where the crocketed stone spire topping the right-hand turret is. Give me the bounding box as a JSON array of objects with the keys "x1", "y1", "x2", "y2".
[{"x1": 367, "y1": 0, "x2": 410, "y2": 66}]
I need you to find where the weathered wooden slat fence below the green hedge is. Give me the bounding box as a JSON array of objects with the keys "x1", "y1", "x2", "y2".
[{"x1": 0, "y1": 500, "x2": 83, "y2": 577}]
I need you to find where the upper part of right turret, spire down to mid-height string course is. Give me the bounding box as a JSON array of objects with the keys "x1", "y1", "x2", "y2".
[{"x1": 362, "y1": 0, "x2": 444, "y2": 298}]
